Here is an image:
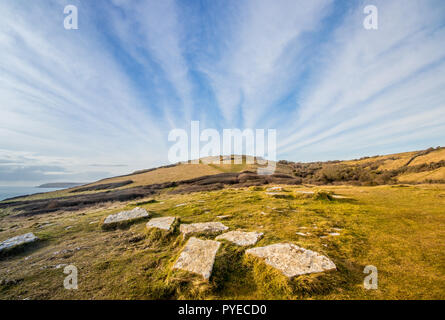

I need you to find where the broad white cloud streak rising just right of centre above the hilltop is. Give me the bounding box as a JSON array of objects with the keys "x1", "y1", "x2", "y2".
[{"x1": 201, "y1": 0, "x2": 333, "y2": 127}]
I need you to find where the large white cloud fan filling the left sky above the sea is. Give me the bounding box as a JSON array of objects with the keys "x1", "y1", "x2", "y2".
[{"x1": 0, "y1": 1, "x2": 170, "y2": 181}]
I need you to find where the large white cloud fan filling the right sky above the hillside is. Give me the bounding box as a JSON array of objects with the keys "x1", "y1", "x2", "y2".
[{"x1": 280, "y1": 1, "x2": 445, "y2": 160}]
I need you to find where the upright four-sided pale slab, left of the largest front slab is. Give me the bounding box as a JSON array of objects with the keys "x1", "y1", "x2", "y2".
[{"x1": 173, "y1": 237, "x2": 221, "y2": 280}]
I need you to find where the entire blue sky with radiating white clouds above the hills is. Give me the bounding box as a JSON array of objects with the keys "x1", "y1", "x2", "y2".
[{"x1": 0, "y1": 0, "x2": 445, "y2": 185}]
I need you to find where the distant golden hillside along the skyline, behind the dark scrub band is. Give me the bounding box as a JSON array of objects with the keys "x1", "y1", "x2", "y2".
[{"x1": 6, "y1": 147, "x2": 445, "y2": 204}]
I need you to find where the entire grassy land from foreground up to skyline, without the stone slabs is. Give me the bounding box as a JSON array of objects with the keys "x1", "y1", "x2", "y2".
[{"x1": 0, "y1": 148, "x2": 445, "y2": 299}]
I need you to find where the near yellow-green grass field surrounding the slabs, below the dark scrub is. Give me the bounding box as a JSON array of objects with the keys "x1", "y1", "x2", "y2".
[{"x1": 0, "y1": 185, "x2": 445, "y2": 299}]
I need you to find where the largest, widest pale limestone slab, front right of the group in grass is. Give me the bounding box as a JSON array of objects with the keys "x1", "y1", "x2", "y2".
[{"x1": 246, "y1": 243, "x2": 336, "y2": 278}]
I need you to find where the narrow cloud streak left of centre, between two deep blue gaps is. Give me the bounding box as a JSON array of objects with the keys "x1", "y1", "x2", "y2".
[{"x1": 106, "y1": 0, "x2": 193, "y2": 128}]
